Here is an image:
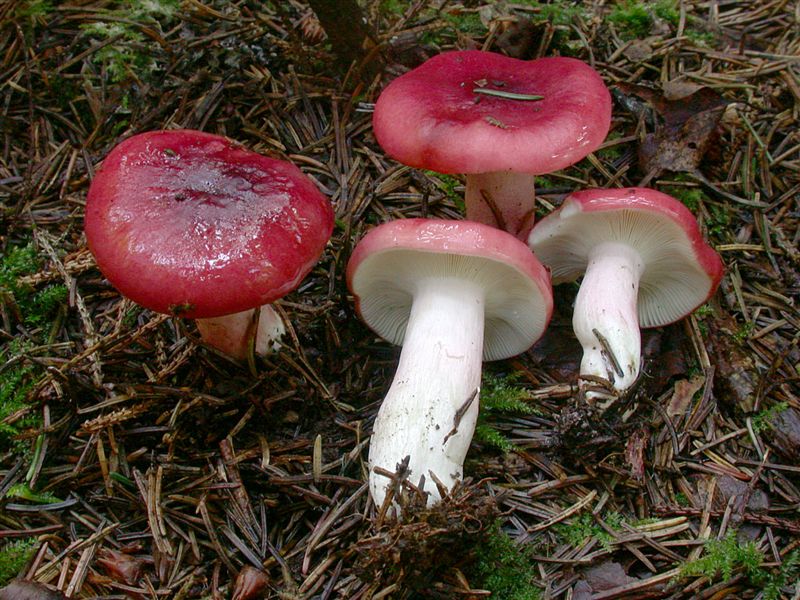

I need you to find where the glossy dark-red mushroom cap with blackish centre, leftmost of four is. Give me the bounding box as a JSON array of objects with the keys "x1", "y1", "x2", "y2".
[{"x1": 85, "y1": 130, "x2": 333, "y2": 318}]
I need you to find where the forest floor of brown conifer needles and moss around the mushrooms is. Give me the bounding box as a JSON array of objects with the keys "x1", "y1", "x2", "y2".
[{"x1": 0, "y1": 0, "x2": 800, "y2": 600}]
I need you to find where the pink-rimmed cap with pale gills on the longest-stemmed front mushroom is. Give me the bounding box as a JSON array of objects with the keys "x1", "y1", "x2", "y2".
[{"x1": 347, "y1": 219, "x2": 553, "y2": 360}]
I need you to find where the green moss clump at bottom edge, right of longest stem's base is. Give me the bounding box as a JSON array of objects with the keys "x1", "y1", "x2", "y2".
[{"x1": 468, "y1": 523, "x2": 541, "y2": 600}]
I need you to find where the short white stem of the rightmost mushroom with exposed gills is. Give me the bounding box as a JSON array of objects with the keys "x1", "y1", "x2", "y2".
[{"x1": 572, "y1": 242, "x2": 644, "y2": 397}]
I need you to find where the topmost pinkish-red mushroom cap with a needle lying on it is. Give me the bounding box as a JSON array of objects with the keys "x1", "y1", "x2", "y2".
[{"x1": 372, "y1": 50, "x2": 611, "y2": 175}]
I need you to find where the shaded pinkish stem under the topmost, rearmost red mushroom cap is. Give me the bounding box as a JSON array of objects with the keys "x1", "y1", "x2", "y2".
[{"x1": 465, "y1": 171, "x2": 536, "y2": 241}]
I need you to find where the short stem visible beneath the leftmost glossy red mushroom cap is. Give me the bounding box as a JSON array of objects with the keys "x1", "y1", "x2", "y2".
[{"x1": 196, "y1": 304, "x2": 286, "y2": 360}]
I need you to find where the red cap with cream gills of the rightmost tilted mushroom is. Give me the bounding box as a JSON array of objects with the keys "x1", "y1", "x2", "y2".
[{"x1": 528, "y1": 188, "x2": 723, "y2": 327}]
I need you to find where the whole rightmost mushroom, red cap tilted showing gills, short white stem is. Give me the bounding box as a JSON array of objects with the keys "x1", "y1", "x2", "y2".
[{"x1": 528, "y1": 188, "x2": 723, "y2": 408}]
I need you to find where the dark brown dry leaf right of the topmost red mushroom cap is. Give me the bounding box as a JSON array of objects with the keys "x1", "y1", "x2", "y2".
[{"x1": 617, "y1": 82, "x2": 728, "y2": 185}]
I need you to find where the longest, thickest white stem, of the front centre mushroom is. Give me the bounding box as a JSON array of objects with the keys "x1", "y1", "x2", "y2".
[{"x1": 369, "y1": 276, "x2": 484, "y2": 507}]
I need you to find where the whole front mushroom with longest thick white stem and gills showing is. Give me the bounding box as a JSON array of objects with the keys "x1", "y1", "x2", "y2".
[{"x1": 347, "y1": 219, "x2": 553, "y2": 506}]
